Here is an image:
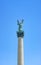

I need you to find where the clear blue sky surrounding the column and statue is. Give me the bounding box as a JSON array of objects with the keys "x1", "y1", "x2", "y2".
[{"x1": 0, "y1": 0, "x2": 41, "y2": 65}]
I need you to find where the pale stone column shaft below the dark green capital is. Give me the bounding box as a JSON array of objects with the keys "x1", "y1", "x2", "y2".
[{"x1": 18, "y1": 37, "x2": 24, "y2": 65}]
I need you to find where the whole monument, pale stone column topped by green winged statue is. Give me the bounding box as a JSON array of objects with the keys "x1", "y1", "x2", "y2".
[{"x1": 17, "y1": 20, "x2": 24, "y2": 65}]
